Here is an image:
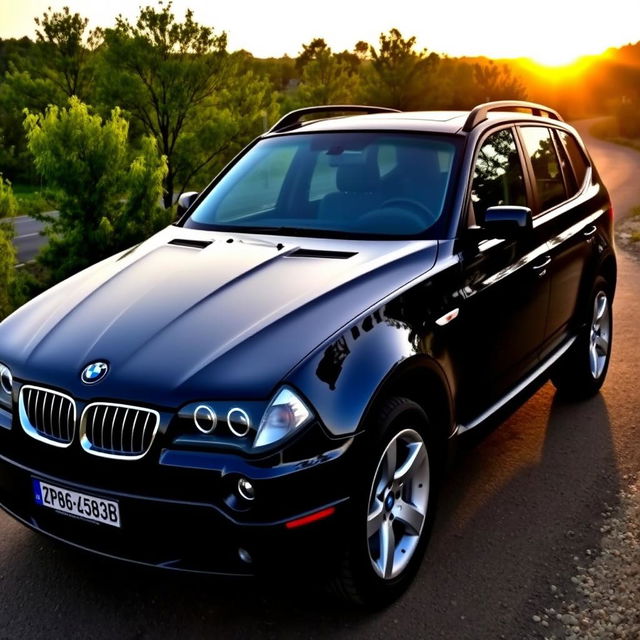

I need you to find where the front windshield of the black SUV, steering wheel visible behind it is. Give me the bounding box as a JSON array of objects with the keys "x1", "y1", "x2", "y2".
[{"x1": 185, "y1": 132, "x2": 456, "y2": 237}]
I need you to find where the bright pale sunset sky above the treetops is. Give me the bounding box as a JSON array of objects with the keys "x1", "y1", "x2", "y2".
[{"x1": 0, "y1": 0, "x2": 640, "y2": 64}]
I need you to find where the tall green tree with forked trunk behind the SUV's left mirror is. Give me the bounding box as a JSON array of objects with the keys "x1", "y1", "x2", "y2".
[{"x1": 99, "y1": 3, "x2": 229, "y2": 207}]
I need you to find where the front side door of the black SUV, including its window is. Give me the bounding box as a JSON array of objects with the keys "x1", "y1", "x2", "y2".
[{"x1": 458, "y1": 128, "x2": 549, "y2": 422}]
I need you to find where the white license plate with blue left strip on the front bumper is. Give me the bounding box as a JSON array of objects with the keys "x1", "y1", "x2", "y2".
[{"x1": 33, "y1": 478, "x2": 120, "y2": 527}]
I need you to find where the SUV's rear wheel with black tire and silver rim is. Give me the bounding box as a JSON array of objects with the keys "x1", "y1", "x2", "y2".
[{"x1": 551, "y1": 276, "x2": 613, "y2": 400}]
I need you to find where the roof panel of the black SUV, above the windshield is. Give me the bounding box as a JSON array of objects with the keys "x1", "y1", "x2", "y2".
[{"x1": 268, "y1": 104, "x2": 562, "y2": 135}]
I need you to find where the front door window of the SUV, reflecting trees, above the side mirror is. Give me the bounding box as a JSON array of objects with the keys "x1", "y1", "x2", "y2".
[{"x1": 471, "y1": 129, "x2": 527, "y2": 220}]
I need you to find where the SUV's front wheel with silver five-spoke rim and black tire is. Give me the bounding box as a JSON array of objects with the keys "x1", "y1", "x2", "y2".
[{"x1": 331, "y1": 398, "x2": 439, "y2": 608}]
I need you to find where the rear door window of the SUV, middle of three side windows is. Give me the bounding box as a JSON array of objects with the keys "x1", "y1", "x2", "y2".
[{"x1": 520, "y1": 127, "x2": 567, "y2": 211}]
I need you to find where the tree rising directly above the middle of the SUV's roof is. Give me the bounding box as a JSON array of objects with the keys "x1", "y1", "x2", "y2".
[{"x1": 356, "y1": 29, "x2": 438, "y2": 111}]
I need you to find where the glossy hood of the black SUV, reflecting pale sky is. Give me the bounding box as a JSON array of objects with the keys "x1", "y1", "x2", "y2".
[{"x1": 0, "y1": 227, "x2": 437, "y2": 407}]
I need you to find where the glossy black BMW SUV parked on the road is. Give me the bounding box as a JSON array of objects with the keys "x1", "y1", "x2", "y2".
[{"x1": 0, "y1": 102, "x2": 616, "y2": 604}]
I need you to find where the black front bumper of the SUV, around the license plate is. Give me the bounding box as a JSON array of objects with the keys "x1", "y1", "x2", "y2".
[{"x1": 0, "y1": 420, "x2": 353, "y2": 575}]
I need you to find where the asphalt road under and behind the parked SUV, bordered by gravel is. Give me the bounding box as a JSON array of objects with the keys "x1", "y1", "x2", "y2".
[{"x1": 0, "y1": 121, "x2": 640, "y2": 640}]
